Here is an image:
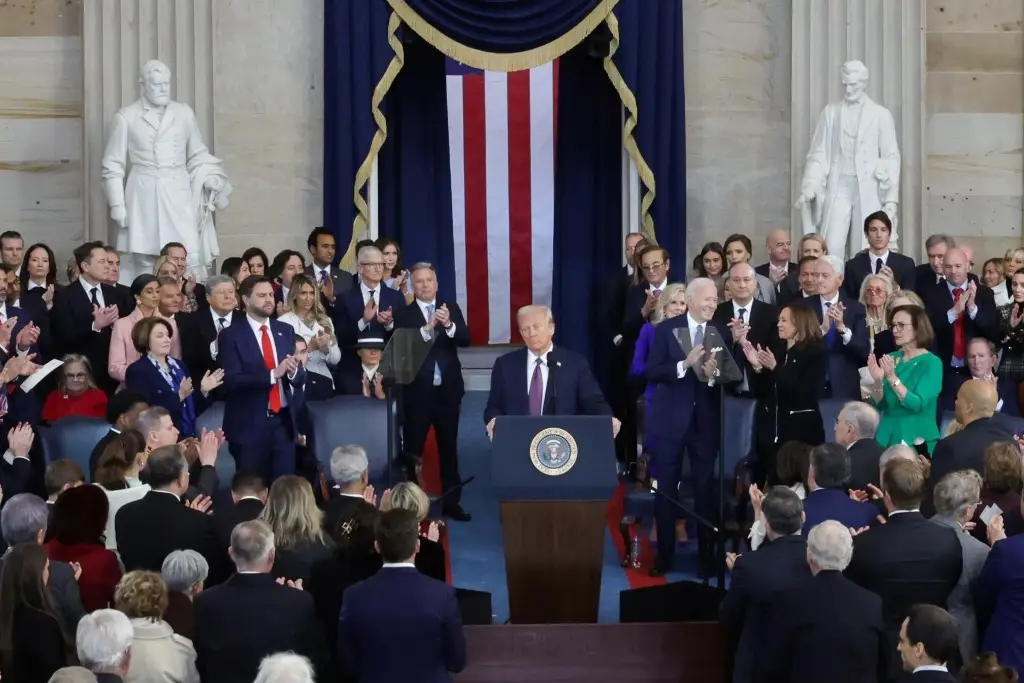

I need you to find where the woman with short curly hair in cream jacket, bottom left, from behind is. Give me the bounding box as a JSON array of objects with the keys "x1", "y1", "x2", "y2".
[{"x1": 114, "y1": 571, "x2": 199, "y2": 683}]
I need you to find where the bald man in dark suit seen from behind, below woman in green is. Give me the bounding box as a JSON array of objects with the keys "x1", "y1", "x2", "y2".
[{"x1": 930, "y1": 378, "x2": 1014, "y2": 481}]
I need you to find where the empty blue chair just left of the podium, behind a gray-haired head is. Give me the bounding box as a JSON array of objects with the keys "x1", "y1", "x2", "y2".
[{"x1": 306, "y1": 396, "x2": 398, "y2": 492}]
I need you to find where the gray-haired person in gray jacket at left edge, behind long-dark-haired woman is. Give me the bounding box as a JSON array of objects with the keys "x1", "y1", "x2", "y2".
[{"x1": 0, "y1": 494, "x2": 85, "y2": 633}]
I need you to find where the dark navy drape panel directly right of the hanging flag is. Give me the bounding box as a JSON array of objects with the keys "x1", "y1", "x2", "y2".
[{"x1": 552, "y1": 45, "x2": 623, "y2": 361}]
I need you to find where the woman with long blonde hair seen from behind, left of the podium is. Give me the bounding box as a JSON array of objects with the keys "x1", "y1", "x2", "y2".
[{"x1": 259, "y1": 475, "x2": 335, "y2": 581}]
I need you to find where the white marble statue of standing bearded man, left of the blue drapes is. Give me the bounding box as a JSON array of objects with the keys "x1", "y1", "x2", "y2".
[{"x1": 102, "y1": 59, "x2": 231, "y2": 284}]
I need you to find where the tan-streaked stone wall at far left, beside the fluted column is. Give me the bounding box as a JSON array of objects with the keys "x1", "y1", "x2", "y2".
[{"x1": 0, "y1": 0, "x2": 84, "y2": 271}]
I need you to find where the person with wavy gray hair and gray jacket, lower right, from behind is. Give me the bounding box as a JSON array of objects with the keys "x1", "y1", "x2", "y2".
[{"x1": 932, "y1": 470, "x2": 988, "y2": 663}]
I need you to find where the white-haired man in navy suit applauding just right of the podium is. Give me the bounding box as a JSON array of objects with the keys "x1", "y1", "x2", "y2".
[{"x1": 646, "y1": 278, "x2": 742, "y2": 577}]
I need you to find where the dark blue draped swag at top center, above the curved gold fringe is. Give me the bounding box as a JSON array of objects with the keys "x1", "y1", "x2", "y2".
[{"x1": 391, "y1": 0, "x2": 600, "y2": 52}]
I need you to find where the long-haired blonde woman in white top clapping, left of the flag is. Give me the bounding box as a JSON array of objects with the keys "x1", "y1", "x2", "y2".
[{"x1": 278, "y1": 274, "x2": 341, "y2": 400}]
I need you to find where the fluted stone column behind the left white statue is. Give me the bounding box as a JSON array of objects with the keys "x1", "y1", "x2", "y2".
[{"x1": 82, "y1": 0, "x2": 217, "y2": 242}]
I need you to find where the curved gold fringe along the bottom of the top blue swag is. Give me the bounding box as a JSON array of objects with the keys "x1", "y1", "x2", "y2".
[{"x1": 388, "y1": 0, "x2": 618, "y2": 72}]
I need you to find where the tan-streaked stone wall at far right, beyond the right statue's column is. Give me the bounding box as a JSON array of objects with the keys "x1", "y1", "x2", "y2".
[{"x1": 925, "y1": 0, "x2": 1024, "y2": 260}]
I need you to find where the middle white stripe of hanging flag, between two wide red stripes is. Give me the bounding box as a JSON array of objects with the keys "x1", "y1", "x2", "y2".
[{"x1": 483, "y1": 72, "x2": 511, "y2": 344}]
